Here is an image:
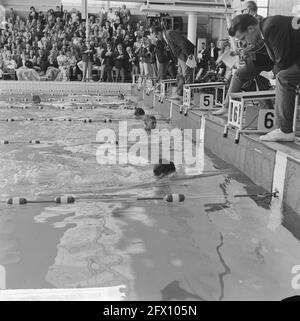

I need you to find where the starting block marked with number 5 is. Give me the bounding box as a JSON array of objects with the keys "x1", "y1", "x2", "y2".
[{"x1": 183, "y1": 82, "x2": 226, "y2": 113}]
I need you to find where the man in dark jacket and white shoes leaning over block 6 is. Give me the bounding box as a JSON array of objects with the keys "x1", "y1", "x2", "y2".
[{"x1": 229, "y1": 14, "x2": 300, "y2": 142}]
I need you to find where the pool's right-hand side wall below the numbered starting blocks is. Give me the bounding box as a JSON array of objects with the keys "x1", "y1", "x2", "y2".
[{"x1": 132, "y1": 87, "x2": 300, "y2": 216}]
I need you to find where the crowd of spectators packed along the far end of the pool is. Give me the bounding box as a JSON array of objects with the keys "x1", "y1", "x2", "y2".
[{"x1": 0, "y1": 5, "x2": 176, "y2": 82}]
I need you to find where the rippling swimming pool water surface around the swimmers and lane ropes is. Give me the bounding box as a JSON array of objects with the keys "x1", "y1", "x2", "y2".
[{"x1": 0, "y1": 94, "x2": 300, "y2": 300}]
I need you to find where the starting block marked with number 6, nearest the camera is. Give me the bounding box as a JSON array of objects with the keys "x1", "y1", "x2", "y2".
[{"x1": 223, "y1": 90, "x2": 275, "y2": 144}]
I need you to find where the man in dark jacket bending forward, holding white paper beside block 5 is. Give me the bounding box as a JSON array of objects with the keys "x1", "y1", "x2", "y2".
[{"x1": 163, "y1": 30, "x2": 195, "y2": 99}]
